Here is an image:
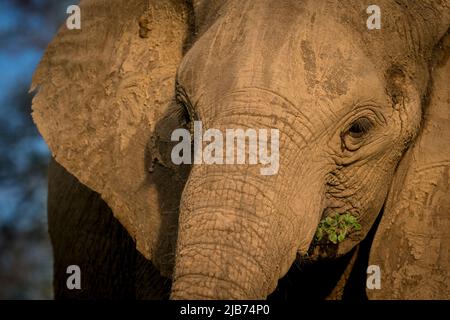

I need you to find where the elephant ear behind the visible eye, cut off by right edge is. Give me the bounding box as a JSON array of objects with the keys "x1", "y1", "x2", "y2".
[{"x1": 367, "y1": 32, "x2": 450, "y2": 299}]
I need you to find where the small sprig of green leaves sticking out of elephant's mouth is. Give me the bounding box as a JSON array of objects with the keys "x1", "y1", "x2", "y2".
[{"x1": 315, "y1": 213, "x2": 361, "y2": 244}]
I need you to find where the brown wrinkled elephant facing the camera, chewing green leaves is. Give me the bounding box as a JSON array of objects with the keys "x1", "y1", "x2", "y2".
[{"x1": 31, "y1": 0, "x2": 450, "y2": 300}]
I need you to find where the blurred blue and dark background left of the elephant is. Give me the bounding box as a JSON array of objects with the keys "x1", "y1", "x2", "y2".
[{"x1": 0, "y1": 0, "x2": 76, "y2": 299}]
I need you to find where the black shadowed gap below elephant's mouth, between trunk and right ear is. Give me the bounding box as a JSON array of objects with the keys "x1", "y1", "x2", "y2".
[{"x1": 267, "y1": 207, "x2": 384, "y2": 301}]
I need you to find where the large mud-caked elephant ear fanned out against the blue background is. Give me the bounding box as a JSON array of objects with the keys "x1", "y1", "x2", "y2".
[{"x1": 31, "y1": 0, "x2": 190, "y2": 275}]
